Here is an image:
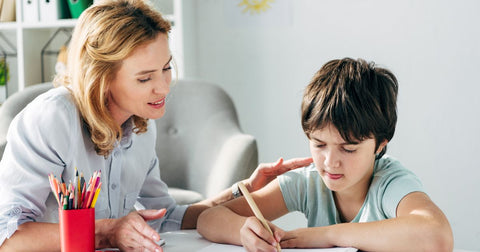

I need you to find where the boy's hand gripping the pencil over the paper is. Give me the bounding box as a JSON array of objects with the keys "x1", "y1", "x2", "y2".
[{"x1": 240, "y1": 216, "x2": 285, "y2": 252}]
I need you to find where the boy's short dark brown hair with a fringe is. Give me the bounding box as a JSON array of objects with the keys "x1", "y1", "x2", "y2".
[{"x1": 302, "y1": 58, "x2": 398, "y2": 158}]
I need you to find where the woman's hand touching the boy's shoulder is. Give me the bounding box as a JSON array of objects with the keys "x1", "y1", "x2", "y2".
[{"x1": 243, "y1": 157, "x2": 313, "y2": 192}]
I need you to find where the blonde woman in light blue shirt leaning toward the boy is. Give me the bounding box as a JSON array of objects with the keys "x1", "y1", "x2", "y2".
[{"x1": 0, "y1": 0, "x2": 311, "y2": 251}]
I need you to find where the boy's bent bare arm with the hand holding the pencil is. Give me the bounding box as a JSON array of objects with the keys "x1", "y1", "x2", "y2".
[{"x1": 197, "y1": 179, "x2": 288, "y2": 245}]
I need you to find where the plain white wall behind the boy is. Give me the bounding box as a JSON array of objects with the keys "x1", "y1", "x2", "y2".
[{"x1": 183, "y1": 0, "x2": 480, "y2": 250}]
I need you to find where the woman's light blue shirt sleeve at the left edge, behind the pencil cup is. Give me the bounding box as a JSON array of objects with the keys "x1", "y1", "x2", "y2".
[{"x1": 0, "y1": 90, "x2": 77, "y2": 245}]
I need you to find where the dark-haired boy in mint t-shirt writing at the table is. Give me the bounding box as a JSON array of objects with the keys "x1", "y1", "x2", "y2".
[{"x1": 197, "y1": 58, "x2": 453, "y2": 251}]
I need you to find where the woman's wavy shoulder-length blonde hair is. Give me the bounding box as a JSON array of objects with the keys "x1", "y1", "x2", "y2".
[{"x1": 55, "y1": 0, "x2": 171, "y2": 157}]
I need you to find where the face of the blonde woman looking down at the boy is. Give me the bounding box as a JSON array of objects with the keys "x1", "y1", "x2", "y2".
[{"x1": 108, "y1": 34, "x2": 172, "y2": 125}]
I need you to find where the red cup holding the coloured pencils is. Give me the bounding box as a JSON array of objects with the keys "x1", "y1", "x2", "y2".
[{"x1": 58, "y1": 208, "x2": 95, "y2": 252}]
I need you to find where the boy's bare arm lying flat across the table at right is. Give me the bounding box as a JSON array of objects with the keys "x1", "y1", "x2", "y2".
[{"x1": 281, "y1": 192, "x2": 453, "y2": 251}]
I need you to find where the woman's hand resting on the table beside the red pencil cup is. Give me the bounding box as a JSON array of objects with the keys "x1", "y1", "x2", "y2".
[{"x1": 99, "y1": 208, "x2": 166, "y2": 251}]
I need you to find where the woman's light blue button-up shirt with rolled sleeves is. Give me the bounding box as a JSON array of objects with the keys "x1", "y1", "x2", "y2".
[{"x1": 0, "y1": 87, "x2": 187, "y2": 245}]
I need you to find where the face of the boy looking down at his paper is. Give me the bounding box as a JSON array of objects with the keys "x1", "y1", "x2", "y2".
[{"x1": 310, "y1": 124, "x2": 387, "y2": 196}]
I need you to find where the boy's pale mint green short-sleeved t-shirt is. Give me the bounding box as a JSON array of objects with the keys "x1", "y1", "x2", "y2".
[{"x1": 278, "y1": 156, "x2": 423, "y2": 227}]
